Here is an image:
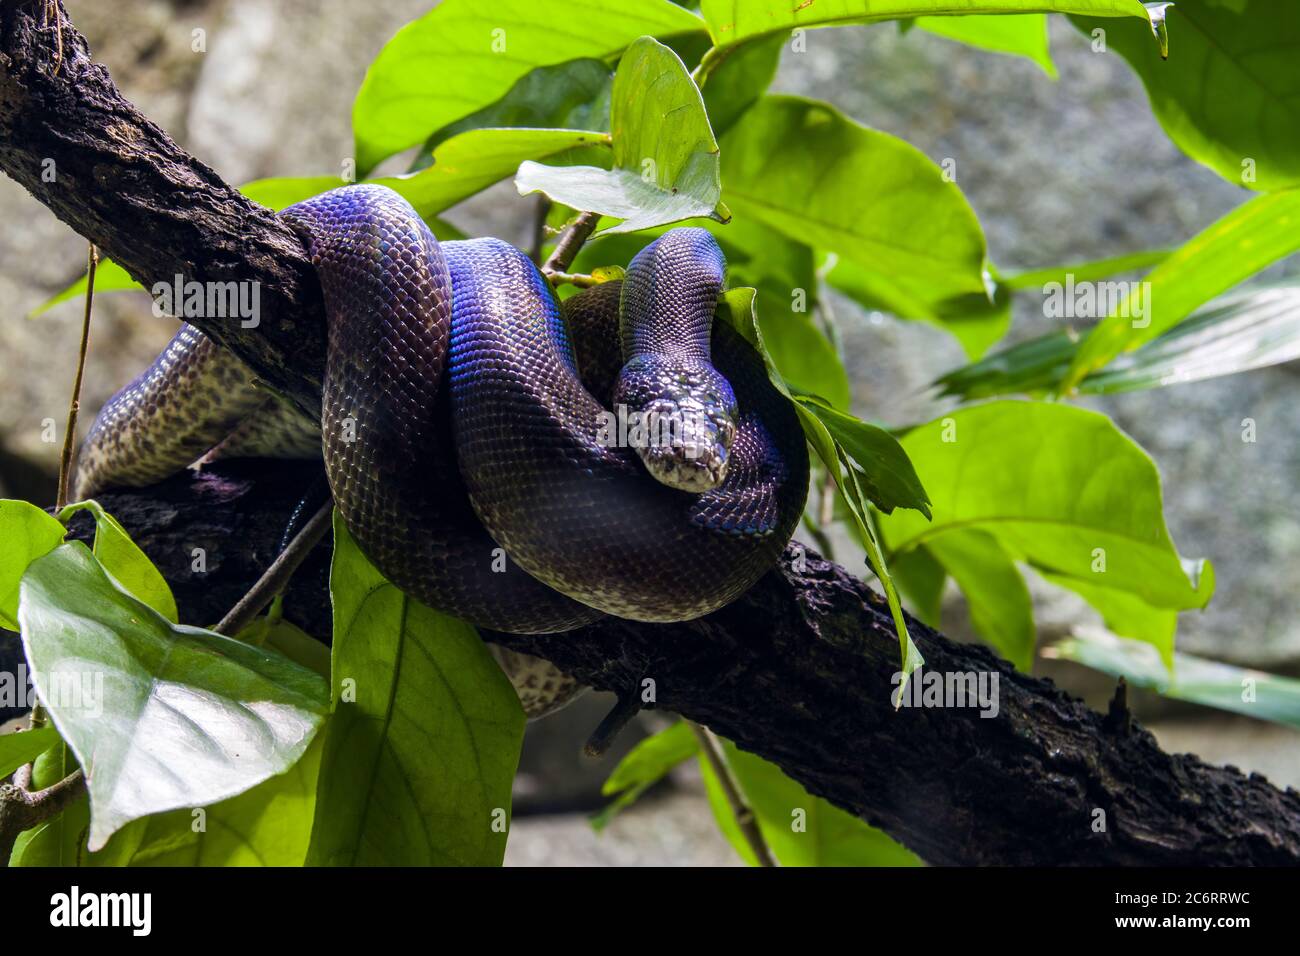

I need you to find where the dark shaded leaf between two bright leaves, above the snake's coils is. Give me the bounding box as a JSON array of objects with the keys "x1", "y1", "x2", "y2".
[{"x1": 411, "y1": 59, "x2": 614, "y2": 172}]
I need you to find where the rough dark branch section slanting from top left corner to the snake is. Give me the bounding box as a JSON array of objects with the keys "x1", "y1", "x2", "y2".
[{"x1": 0, "y1": 0, "x2": 325, "y2": 414}]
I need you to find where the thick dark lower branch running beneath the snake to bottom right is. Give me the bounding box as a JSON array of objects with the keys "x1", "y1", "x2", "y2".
[{"x1": 68, "y1": 462, "x2": 1300, "y2": 865}]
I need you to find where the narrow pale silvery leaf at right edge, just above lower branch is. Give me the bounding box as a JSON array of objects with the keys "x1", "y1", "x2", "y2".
[{"x1": 1044, "y1": 632, "x2": 1300, "y2": 727}]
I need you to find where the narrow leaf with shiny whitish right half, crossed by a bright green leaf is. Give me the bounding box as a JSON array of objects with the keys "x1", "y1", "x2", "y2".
[{"x1": 935, "y1": 282, "x2": 1300, "y2": 399}]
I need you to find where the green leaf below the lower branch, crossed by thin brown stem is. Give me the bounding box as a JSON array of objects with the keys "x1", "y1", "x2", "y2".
[{"x1": 699, "y1": 740, "x2": 920, "y2": 866}]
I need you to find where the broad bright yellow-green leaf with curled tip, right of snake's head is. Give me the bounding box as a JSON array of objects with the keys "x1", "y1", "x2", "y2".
[{"x1": 881, "y1": 402, "x2": 1213, "y2": 610}]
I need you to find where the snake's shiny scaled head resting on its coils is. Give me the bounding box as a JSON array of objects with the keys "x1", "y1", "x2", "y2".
[{"x1": 614, "y1": 356, "x2": 737, "y2": 494}]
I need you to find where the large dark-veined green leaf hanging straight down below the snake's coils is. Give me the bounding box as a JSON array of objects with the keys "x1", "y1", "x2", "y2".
[{"x1": 308, "y1": 512, "x2": 524, "y2": 866}]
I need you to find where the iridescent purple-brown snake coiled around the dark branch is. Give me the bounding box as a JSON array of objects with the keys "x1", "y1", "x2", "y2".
[{"x1": 74, "y1": 183, "x2": 809, "y2": 718}]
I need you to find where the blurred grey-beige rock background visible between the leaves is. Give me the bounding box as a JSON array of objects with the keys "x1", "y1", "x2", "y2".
[{"x1": 0, "y1": 0, "x2": 1300, "y2": 865}]
